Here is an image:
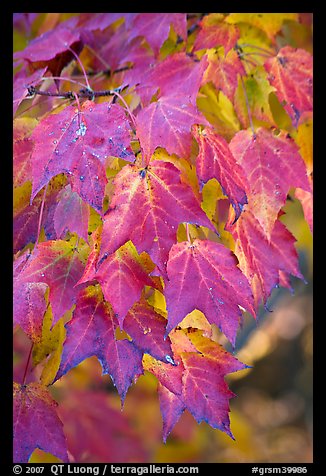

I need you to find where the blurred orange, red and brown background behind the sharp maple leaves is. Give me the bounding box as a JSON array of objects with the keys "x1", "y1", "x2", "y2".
[{"x1": 14, "y1": 14, "x2": 313, "y2": 463}]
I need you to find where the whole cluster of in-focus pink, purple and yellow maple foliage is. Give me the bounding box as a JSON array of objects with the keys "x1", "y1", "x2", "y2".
[{"x1": 13, "y1": 13, "x2": 313, "y2": 462}]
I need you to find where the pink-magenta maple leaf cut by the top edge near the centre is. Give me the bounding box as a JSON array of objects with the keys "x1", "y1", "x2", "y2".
[{"x1": 130, "y1": 13, "x2": 187, "y2": 55}]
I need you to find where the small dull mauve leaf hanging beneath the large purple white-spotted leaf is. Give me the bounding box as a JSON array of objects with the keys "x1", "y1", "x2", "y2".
[{"x1": 53, "y1": 185, "x2": 89, "y2": 241}]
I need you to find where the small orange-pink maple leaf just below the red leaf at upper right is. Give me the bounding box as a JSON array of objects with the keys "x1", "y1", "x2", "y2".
[{"x1": 202, "y1": 50, "x2": 246, "y2": 101}]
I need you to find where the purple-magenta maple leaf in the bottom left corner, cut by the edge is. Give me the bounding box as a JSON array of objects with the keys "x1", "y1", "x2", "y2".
[{"x1": 13, "y1": 383, "x2": 68, "y2": 463}]
